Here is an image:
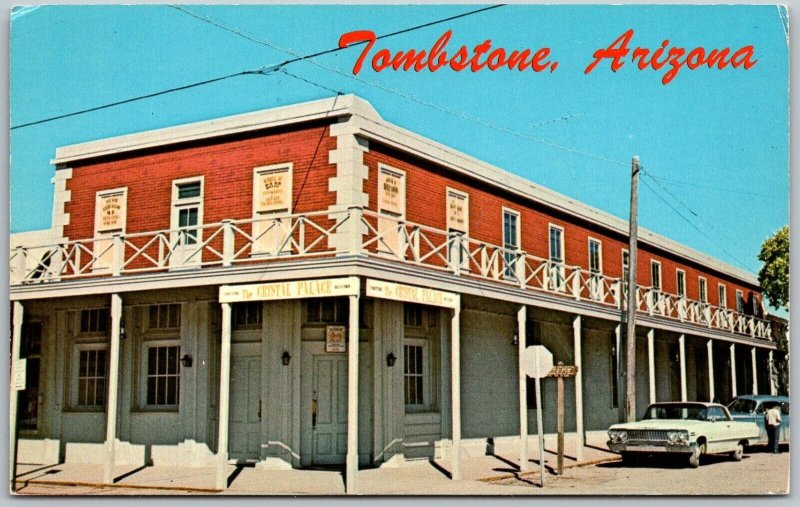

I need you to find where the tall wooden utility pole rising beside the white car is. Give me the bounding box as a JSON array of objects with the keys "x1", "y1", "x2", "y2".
[{"x1": 625, "y1": 156, "x2": 639, "y2": 422}]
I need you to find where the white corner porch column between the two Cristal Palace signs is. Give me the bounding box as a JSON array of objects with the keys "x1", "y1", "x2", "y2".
[{"x1": 345, "y1": 296, "x2": 359, "y2": 494}]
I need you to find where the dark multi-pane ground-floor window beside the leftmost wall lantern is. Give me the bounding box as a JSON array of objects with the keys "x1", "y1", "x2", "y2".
[{"x1": 143, "y1": 341, "x2": 181, "y2": 408}]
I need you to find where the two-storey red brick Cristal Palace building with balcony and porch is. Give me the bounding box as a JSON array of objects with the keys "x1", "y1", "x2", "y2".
[{"x1": 10, "y1": 95, "x2": 776, "y2": 488}]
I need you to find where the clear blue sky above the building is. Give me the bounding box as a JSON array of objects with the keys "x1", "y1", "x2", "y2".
[{"x1": 10, "y1": 5, "x2": 789, "y2": 282}]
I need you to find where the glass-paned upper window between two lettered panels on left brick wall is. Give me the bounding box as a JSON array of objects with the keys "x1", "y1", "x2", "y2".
[{"x1": 170, "y1": 176, "x2": 203, "y2": 267}]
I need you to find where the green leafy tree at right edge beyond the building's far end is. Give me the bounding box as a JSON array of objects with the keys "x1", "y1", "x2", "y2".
[{"x1": 758, "y1": 226, "x2": 789, "y2": 394}]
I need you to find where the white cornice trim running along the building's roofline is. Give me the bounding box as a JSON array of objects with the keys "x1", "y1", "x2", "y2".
[{"x1": 51, "y1": 95, "x2": 758, "y2": 286}]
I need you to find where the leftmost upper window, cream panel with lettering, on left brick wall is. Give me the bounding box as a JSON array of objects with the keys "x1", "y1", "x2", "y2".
[{"x1": 92, "y1": 187, "x2": 128, "y2": 270}]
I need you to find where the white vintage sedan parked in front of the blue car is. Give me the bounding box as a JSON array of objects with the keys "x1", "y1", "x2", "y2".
[{"x1": 608, "y1": 402, "x2": 759, "y2": 468}]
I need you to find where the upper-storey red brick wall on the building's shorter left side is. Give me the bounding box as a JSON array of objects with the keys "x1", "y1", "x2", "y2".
[{"x1": 64, "y1": 124, "x2": 336, "y2": 239}]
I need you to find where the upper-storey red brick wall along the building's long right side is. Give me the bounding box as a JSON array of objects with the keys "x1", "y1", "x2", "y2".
[{"x1": 364, "y1": 143, "x2": 754, "y2": 309}]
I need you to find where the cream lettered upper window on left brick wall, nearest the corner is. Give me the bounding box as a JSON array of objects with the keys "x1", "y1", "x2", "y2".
[{"x1": 252, "y1": 163, "x2": 293, "y2": 255}]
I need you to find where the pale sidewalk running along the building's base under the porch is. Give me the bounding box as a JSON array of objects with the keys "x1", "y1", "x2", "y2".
[{"x1": 12, "y1": 431, "x2": 616, "y2": 495}]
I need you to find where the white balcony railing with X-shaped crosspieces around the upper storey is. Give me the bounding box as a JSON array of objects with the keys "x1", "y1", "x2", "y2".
[{"x1": 10, "y1": 208, "x2": 772, "y2": 340}]
